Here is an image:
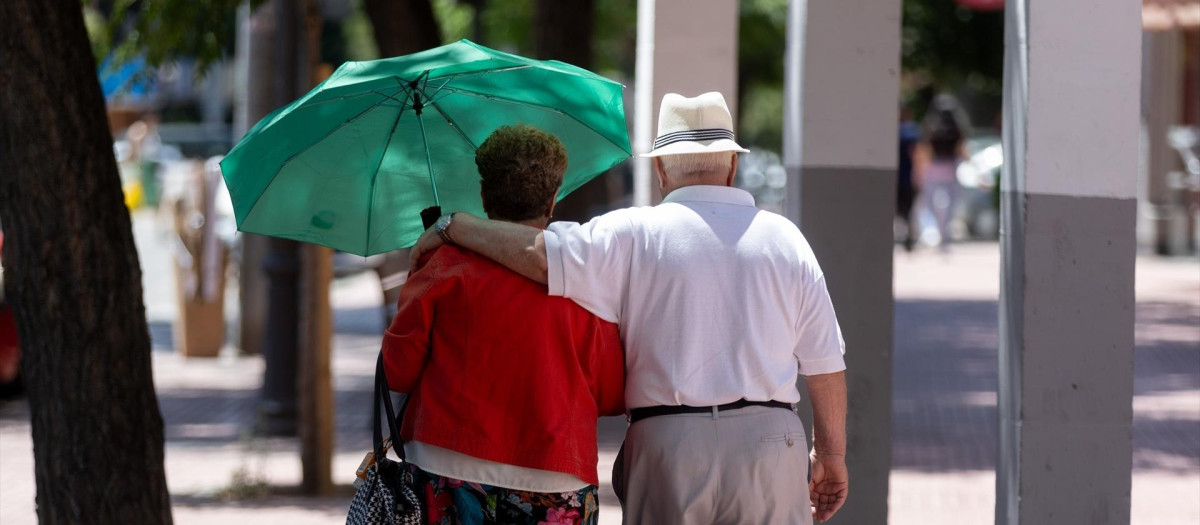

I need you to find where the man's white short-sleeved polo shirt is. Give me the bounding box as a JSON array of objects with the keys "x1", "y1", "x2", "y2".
[{"x1": 545, "y1": 186, "x2": 846, "y2": 409}]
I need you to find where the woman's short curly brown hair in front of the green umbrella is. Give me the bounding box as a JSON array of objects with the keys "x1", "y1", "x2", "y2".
[{"x1": 475, "y1": 125, "x2": 566, "y2": 221}]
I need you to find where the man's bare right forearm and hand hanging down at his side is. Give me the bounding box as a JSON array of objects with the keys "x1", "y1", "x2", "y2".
[{"x1": 805, "y1": 372, "x2": 850, "y2": 521}]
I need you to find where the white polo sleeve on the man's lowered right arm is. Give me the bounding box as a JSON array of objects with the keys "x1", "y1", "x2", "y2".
[{"x1": 796, "y1": 271, "x2": 846, "y2": 375}]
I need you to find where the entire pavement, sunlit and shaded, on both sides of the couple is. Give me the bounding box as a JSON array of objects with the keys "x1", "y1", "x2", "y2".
[{"x1": 0, "y1": 212, "x2": 1200, "y2": 525}]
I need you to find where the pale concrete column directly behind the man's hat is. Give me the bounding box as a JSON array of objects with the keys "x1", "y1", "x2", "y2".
[{"x1": 634, "y1": 0, "x2": 738, "y2": 206}]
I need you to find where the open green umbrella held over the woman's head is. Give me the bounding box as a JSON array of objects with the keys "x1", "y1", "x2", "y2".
[{"x1": 221, "y1": 40, "x2": 630, "y2": 255}]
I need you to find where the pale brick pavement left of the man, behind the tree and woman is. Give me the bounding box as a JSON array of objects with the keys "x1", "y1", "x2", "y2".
[{"x1": 0, "y1": 211, "x2": 624, "y2": 525}]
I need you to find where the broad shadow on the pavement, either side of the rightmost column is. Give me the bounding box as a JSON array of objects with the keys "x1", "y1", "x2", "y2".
[{"x1": 892, "y1": 300, "x2": 1200, "y2": 473}]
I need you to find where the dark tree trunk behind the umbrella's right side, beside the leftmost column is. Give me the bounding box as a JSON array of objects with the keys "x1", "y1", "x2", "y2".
[{"x1": 534, "y1": 0, "x2": 612, "y2": 222}]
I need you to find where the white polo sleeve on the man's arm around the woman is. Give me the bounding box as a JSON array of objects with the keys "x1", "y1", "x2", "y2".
[{"x1": 542, "y1": 210, "x2": 634, "y2": 322}]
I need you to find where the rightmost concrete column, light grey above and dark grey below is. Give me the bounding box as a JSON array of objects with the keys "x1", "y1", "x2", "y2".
[{"x1": 996, "y1": 0, "x2": 1141, "y2": 524}]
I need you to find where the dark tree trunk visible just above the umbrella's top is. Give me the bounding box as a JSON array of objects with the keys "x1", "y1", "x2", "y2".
[{"x1": 362, "y1": 0, "x2": 442, "y2": 58}]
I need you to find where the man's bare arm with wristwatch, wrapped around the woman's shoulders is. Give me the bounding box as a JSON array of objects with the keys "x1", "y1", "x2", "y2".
[{"x1": 409, "y1": 212, "x2": 546, "y2": 284}]
